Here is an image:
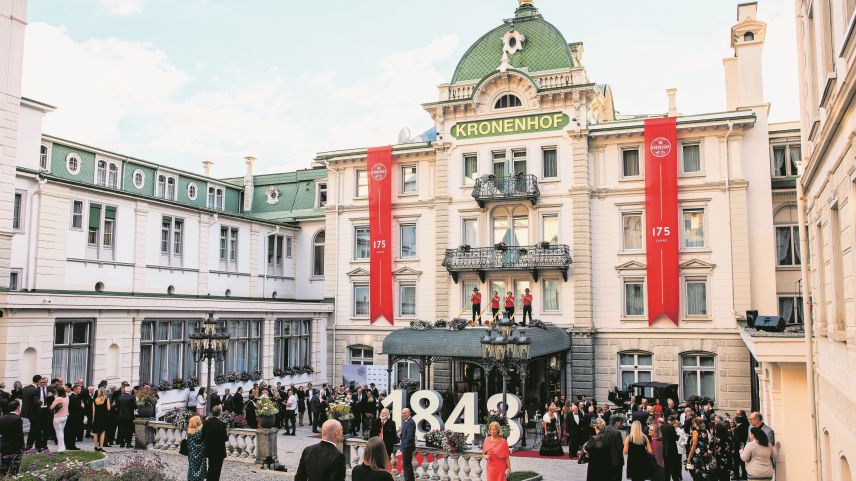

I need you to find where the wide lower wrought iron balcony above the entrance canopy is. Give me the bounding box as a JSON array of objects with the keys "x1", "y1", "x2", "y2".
[{"x1": 443, "y1": 242, "x2": 571, "y2": 282}]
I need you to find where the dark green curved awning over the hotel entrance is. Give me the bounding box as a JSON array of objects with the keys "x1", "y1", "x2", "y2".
[{"x1": 382, "y1": 326, "x2": 571, "y2": 359}]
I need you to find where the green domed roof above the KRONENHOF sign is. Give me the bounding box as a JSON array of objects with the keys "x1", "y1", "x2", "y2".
[{"x1": 452, "y1": 6, "x2": 574, "y2": 83}]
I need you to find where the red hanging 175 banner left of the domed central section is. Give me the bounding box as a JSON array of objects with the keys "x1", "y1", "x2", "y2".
[{"x1": 366, "y1": 146, "x2": 394, "y2": 324}]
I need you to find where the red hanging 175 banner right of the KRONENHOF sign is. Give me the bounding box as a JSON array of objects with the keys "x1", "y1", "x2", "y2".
[{"x1": 644, "y1": 117, "x2": 680, "y2": 326}]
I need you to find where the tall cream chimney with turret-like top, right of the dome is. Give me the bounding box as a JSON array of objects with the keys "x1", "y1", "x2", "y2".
[{"x1": 722, "y1": 2, "x2": 767, "y2": 110}]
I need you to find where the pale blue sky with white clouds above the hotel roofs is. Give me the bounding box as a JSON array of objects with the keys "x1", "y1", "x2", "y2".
[{"x1": 23, "y1": 0, "x2": 799, "y2": 177}]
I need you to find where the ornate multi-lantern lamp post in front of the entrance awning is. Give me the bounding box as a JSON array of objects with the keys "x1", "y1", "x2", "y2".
[{"x1": 481, "y1": 314, "x2": 532, "y2": 447}]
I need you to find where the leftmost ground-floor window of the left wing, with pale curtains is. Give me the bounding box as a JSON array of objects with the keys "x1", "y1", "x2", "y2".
[{"x1": 51, "y1": 319, "x2": 92, "y2": 382}]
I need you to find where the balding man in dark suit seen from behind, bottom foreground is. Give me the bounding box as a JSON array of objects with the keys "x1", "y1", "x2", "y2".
[{"x1": 294, "y1": 419, "x2": 345, "y2": 481}]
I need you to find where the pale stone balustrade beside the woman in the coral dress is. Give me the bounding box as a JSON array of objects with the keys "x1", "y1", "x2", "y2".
[{"x1": 345, "y1": 438, "x2": 486, "y2": 481}]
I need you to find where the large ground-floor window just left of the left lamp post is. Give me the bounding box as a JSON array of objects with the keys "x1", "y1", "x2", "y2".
[{"x1": 140, "y1": 320, "x2": 198, "y2": 385}]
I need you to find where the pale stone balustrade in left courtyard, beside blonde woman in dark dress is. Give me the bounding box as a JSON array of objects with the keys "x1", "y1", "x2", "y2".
[{"x1": 135, "y1": 419, "x2": 277, "y2": 464}]
